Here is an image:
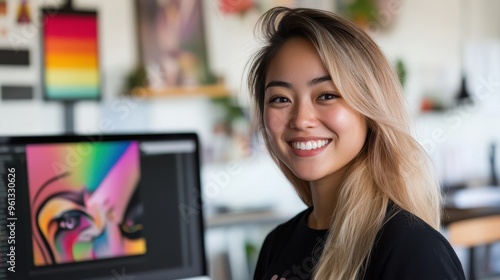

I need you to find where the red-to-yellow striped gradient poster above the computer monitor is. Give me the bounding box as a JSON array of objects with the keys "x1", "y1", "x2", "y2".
[{"x1": 42, "y1": 12, "x2": 100, "y2": 100}]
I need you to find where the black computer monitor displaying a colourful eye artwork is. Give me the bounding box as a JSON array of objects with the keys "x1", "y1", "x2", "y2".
[{"x1": 0, "y1": 133, "x2": 208, "y2": 280}]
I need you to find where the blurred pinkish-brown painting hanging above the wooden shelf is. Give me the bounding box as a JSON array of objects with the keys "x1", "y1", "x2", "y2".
[{"x1": 136, "y1": 0, "x2": 215, "y2": 89}]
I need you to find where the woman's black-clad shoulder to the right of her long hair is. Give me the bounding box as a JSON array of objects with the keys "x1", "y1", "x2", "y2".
[{"x1": 367, "y1": 207, "x2": 465, "y2": 279}]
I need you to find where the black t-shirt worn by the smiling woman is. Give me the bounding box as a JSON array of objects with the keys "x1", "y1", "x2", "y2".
[{"x1": 254, "y1": 204, "x2": 465, "y2": 280}]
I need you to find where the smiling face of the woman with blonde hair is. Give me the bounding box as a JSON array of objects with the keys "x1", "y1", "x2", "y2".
[{"x1": 263, "y1": 38, "x2": 368, "y2": 186}]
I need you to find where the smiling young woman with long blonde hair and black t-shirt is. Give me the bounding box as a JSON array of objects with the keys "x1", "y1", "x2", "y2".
[{"x1": 249, "y1": 7, "x2": 465, "y2": 280}]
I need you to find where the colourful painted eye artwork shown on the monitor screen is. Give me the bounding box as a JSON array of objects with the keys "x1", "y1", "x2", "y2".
[{"x1": 26, "y1": 142, "x2": 146, "y2": 266}]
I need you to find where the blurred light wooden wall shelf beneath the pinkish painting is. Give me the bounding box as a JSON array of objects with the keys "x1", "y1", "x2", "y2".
[{"x1": 132, "y1": 84, "x2": 229, "y2": 98}]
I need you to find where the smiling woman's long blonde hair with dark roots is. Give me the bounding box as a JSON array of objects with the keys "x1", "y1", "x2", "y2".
[{"x1": 248, "y1": 7, "x2": 441, "y2": 280}]
